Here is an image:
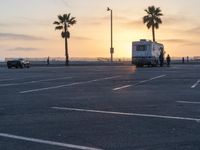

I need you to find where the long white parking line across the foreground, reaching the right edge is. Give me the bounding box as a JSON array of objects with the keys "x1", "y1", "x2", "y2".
[{"x1": 51, "y1": 107, "x2": 200, "y2": 122}]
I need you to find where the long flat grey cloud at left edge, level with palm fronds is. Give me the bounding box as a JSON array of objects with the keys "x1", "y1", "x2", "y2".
[{"x1": 0, "y1": 33, "x2": 47, "y2": 41}]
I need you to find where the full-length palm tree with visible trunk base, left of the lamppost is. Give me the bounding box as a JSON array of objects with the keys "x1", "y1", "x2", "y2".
[{"x1": 53, "y1": 13, "x2": 76, "y2": 66}]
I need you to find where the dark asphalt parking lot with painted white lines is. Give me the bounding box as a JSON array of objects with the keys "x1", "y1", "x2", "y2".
[{"x1": 0, "y1": 65, "x2": 200, "y2": 150}]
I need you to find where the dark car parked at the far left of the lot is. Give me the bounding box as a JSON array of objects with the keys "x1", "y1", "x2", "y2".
[{"x1": 7, "y1": 58, "x2": 30, "y2": 68}]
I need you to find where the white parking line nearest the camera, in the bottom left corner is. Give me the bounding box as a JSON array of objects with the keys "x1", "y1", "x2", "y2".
[{"x1": 0, "y1": 133, "x2": 102, "y2": 150}]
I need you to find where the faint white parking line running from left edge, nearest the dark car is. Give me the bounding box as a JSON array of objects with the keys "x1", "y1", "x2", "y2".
[{"x1": 0, "y1": 77, "x2": 72, "y2": 87}]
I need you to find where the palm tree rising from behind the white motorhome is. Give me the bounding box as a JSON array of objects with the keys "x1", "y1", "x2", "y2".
[{"x1": 143, "y1": 6, "x2": 163, "y2": 42}]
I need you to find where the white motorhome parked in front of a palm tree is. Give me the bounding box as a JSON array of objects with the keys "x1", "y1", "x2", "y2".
[{"x1": 132, "y1": 39, "x2": 164, "y2": 67}]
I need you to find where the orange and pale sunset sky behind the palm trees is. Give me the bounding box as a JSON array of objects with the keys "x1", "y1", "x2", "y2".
[{"x1": 0, "y1": 0, "x2": 200, "y2": 59}]
